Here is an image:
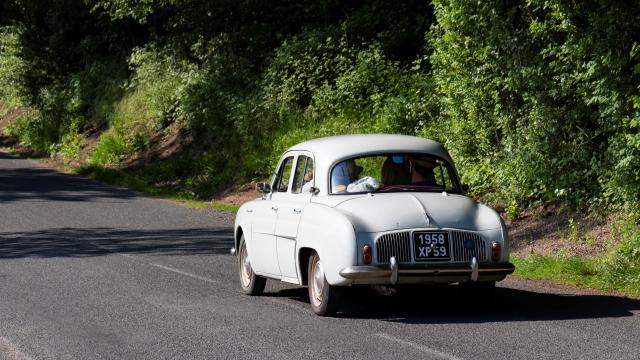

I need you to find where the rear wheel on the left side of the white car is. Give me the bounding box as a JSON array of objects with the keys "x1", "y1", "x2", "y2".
[{"x1": 307, "y1": 253, "x2": 340, "y2": 316}]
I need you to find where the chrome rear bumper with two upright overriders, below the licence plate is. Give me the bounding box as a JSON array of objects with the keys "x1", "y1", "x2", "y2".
[{"x1": 340, "y1": 256, "x2": 515, "y2": 284}]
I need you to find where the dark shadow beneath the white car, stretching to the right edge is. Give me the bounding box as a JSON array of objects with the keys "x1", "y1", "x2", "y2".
[{"x1": 265, "y1": 285, "x2": 640, "y2": 324}]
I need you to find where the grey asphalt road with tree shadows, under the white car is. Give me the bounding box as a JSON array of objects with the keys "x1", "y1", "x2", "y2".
[{"x1": 0, "y1": 153, "x2": 640, "y2": 360}]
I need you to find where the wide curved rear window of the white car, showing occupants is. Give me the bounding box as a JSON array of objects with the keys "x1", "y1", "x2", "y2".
[{"x1": 331, "y1": 153, "x2": 460, "y2": 194}]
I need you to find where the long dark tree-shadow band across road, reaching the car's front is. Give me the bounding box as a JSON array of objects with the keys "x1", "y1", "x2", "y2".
[{"x1": 0, "y1": 228, "x2": 233, "y2": 259}]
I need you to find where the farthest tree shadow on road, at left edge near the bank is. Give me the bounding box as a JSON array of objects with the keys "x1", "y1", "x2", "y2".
[{"x1": 0, "y1": 153, "x2": 137, "y2": 203}]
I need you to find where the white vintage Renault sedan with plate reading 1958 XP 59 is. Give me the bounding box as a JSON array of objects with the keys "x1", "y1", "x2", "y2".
[{"x1": 231, "y1": 135, "x2": 514, "y2": 315}]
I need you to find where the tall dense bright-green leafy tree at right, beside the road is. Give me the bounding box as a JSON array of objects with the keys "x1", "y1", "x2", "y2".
[{"x1": 429, "y1": 0, "x2": 640, "y2": 212}]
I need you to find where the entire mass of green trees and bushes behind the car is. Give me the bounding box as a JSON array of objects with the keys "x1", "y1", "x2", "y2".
[{"x1": 0, "y1": 0, "x2": 640, "y2": 218}]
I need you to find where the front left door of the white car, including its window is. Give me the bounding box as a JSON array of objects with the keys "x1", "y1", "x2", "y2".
[{"x1": 249, "y1": 154, "x2": 295, "y2": 277}]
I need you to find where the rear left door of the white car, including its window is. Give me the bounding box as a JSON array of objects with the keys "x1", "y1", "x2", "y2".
[{"x1": 274, "y1": 152, "x2": 314, "y2": 283}]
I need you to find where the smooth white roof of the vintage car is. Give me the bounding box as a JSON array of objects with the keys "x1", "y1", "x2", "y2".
[{"x1": 289, "y1": 134, "x2": 453, "y2": 163}]
